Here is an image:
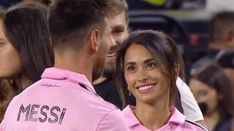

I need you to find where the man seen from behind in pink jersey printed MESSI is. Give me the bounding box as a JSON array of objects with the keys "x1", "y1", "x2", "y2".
[{"x1": 0, "y1": 0, "x2": 128, "y2": 131}]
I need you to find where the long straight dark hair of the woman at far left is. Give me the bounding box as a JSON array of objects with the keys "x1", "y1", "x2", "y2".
[{"x1": 4, "y1": 3, "x2": 54, "y2": 85}]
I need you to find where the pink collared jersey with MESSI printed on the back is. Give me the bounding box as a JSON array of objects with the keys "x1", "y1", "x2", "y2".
[{"x1": 0, "y1": 68, "x2": 128, "y2": 131}]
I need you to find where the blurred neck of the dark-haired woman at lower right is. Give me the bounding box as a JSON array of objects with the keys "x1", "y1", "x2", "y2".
[{"x1": 205, "y1": 111, "x2": 220, "y2": 131}]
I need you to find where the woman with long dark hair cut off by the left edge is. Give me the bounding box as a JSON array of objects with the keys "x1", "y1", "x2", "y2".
[{"x1": 0, "y1": 3, "x2": 54, "y2": 120}]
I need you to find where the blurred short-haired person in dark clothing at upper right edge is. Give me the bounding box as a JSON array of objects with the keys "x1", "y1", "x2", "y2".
[{"x1": 190, "y1": 11, "x2": 234, "y2": 75}]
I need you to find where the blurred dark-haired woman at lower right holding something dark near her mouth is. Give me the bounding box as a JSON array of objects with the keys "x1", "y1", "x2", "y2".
[{"x1": 189, "y1": 64, "x2": 234, "y2": 131}]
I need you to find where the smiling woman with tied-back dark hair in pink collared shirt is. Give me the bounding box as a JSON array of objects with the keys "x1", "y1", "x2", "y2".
[{"x1": 116, "y1": 30, "x2": 205, "y2": 131}]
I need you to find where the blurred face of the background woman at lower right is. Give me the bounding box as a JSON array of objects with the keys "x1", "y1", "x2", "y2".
[{"x1": 189, "y1": 79, "x2": 221, "y2": 116}]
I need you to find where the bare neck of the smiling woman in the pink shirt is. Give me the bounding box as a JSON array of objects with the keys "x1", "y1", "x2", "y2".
[{"x1": 134, "y1": 100, "x2": 171, "y2": 130}]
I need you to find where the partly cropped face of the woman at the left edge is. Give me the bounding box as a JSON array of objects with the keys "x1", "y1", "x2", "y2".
[{"x1": 0, "y1": 19, "x2": 21, "y2": 78}]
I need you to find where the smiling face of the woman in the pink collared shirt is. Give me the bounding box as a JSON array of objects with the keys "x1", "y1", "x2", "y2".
[{"x1": 124, "y1": 43, "x2": 170, "y2": 104}]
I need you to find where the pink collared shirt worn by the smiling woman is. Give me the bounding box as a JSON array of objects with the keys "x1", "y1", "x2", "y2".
[{"x1": 122, "y1": 106, "x2": 206, "y2": 131}]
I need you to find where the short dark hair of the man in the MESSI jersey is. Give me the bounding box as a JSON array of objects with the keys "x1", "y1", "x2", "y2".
[{"x1": 49, "y1": 0, "x2": 108, "y2": 49}]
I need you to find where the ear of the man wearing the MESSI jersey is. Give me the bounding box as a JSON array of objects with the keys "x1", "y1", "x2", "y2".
[{"x1": 90, "y1": 30, "x2": 100, "y2": 52}]
